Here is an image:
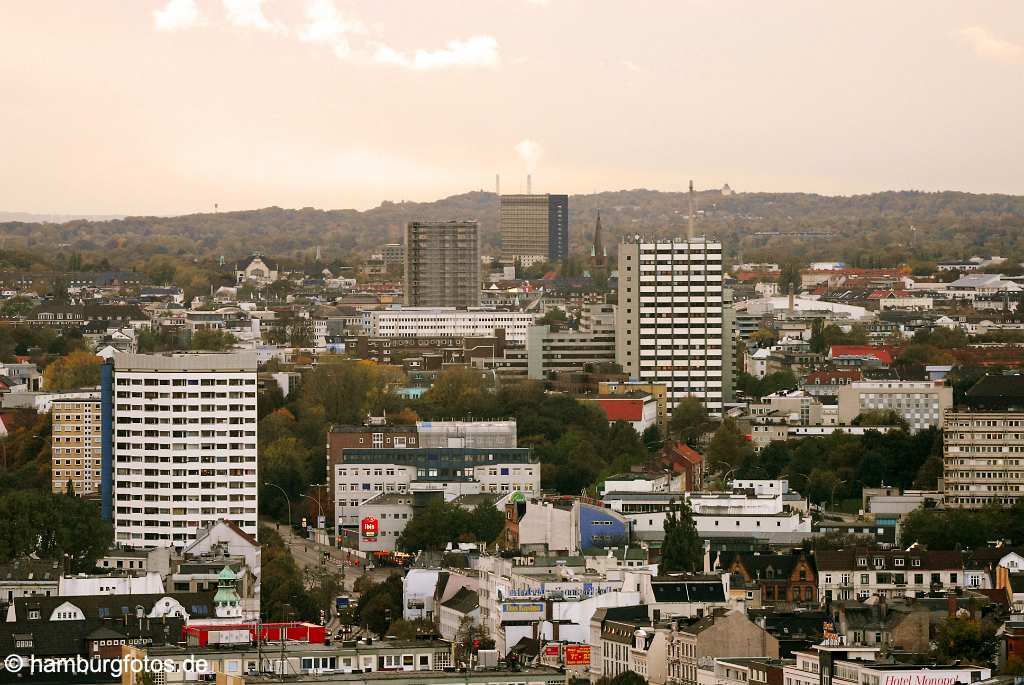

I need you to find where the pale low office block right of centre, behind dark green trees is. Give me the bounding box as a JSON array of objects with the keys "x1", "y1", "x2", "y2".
[{"x1": 838, "y1": 381, "x2": 953, "y2": 430}]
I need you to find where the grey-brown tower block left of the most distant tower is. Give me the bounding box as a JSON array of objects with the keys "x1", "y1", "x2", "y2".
[{"x1": 404, "y1": 221, "x2": 480, "y2": 307}]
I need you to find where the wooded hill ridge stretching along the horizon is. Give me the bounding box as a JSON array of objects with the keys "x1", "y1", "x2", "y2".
[{"x1": 0, "y1": 189, "x2": 1024, "y2": 268}]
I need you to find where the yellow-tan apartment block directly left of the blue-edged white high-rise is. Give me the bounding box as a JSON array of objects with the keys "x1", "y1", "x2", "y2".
[{"x1": 50, "y1": 392, "x2": 102, "y2": 496}]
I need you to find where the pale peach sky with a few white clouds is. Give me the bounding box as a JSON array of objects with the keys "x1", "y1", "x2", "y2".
[{"x1": 0, "y1": 0, "x2": 1024, "y2": 214}]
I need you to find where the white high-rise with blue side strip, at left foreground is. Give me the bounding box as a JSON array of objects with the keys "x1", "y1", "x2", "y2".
[{"x1": 100, "y1": 352, "x2": 259, "y2": 547}]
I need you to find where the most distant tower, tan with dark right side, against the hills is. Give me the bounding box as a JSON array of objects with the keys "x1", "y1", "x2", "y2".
[{"x1": 500, "y1": 195, "x2": 569, "y2": 266}]
